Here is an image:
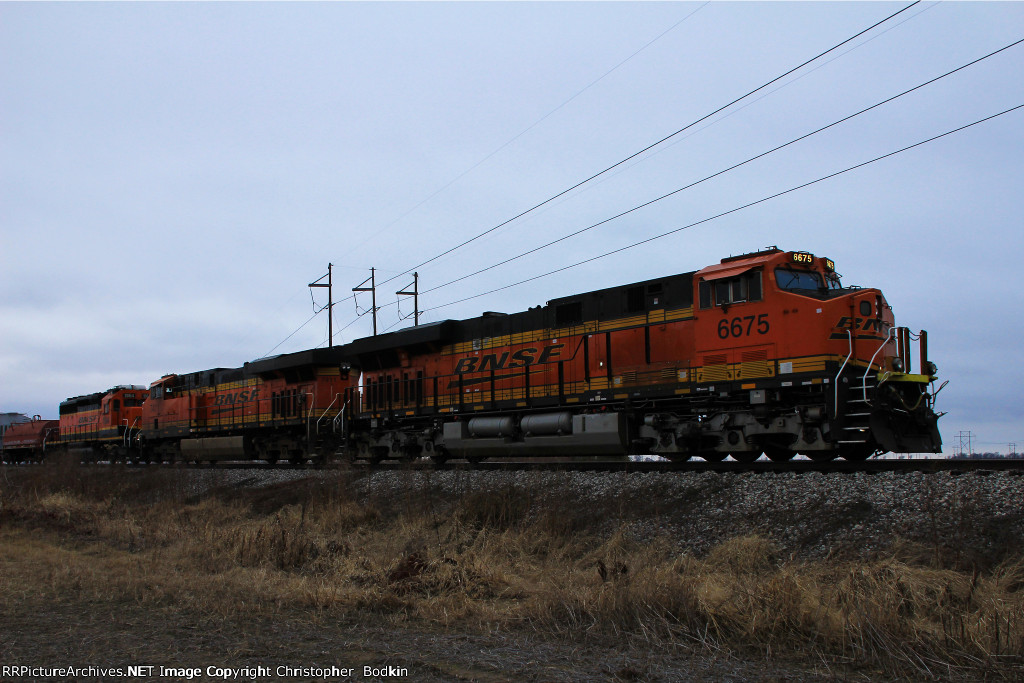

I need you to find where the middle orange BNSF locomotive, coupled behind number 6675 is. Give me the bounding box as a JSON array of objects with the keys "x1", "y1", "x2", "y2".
[{"x1": 138, "y1": 347, "x2": 357, "y2": 463}]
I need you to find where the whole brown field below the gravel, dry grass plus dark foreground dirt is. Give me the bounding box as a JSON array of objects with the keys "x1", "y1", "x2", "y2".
[{"x1": 0, "y1": 466, "x2": 1024, "y2": 681}]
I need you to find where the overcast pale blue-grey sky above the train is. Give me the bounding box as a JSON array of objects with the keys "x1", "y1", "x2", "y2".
[{"x1": 0, "y1": 2, "x2": 1024, "y2": 451}]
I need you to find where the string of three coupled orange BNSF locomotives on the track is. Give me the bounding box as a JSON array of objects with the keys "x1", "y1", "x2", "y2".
[{"x1": 6, "y1": 248, "x2": 941, "y2": 462}]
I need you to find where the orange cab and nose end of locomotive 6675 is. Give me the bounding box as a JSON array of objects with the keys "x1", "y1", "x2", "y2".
[{"x1": 694, "y1": 248, "x2": 941, "y2": 460}]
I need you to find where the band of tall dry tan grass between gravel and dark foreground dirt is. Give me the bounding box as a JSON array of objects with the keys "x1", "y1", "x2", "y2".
[{"x1": 0, "y1": 468, "x2": 1024, "y2": 678}]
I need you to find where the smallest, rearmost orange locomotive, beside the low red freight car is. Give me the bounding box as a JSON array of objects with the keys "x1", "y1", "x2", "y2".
[{"x1": 60, "y1": 386, "x2": 146, "y2": 461}]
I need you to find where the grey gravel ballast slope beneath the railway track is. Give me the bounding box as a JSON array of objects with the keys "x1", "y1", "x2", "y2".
[{"x1": 180, "y1": 470, "x2": 1024, "y2": 563}]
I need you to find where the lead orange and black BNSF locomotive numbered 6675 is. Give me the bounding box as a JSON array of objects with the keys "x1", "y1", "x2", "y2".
[{"x1": 342, "y1": 248, "x2": 941, "y2": 462}]
